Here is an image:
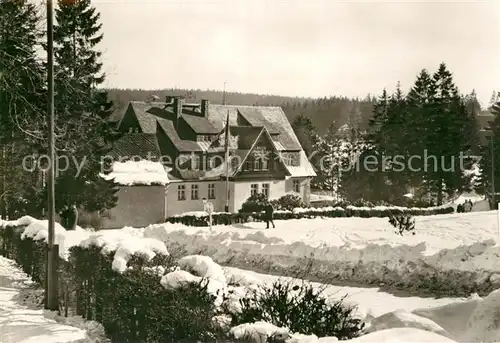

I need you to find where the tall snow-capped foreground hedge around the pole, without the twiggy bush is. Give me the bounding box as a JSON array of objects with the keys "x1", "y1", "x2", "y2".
[{"x1": 0, "y1": 218, "x2": 221, "y2": 343}]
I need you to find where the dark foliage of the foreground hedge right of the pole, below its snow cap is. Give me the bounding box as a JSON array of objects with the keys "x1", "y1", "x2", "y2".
[{"x1": 65, "y1": 245, "x2": 226, "y2": 343}]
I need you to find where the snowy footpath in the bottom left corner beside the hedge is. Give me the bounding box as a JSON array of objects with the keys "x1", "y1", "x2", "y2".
[{"x1": 0, "y1": 256, "x2": 95, "y2": 343}]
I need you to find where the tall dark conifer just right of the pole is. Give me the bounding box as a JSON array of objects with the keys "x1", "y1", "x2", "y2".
[{"x1": 54, "y1": 0, "x2": 118, "y2": 218}]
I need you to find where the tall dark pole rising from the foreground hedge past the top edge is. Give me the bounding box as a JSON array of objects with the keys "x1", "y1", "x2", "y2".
[{"x1": 45, "y1": 0, "x2": 59, "y2": 311}]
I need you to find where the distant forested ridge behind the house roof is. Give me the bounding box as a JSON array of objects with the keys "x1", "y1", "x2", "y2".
[{"x1": 107, "y1": 89, "x2": 374, "y2": 134}]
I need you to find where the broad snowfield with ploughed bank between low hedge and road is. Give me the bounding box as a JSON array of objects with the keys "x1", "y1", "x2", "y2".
[{"x1": 144, "y1": 211, "x2": 500, "y2": 296}]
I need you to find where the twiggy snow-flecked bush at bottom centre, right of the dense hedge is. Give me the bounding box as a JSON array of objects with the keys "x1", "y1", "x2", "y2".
[{"x1": 229, "y1": 281, "x2": 364, "y2": 340}]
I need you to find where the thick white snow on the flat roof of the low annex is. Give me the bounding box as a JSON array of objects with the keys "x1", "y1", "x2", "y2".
[{"x1": 101, "y1": 160, "x2": 169, "y2": 186}]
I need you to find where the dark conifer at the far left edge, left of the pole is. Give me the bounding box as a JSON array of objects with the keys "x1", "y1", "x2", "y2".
[{"x1": 0, "y1": 0, "x2": 45, "y2": 216}]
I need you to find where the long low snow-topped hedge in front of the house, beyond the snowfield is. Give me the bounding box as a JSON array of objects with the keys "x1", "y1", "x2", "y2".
[{"x1": 167, "y1": 206, "x2": 455, "y2": 226}]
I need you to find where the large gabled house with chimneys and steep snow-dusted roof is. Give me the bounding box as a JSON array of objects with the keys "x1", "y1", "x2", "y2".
[{"x1": 106, "y1": 97, "x2": 316, "y2": 222}]
